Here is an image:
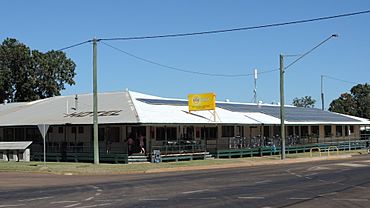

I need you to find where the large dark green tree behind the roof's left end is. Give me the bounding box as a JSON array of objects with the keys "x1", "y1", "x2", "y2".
[{"x1": 0, "y1": 38, "x2": 76, "y2": 103}]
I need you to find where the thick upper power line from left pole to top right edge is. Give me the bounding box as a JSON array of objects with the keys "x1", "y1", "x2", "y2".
[{"x1": 98, "y1": 10, "x2": 370, "y2": 41}]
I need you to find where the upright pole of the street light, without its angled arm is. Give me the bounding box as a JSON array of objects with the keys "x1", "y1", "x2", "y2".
[{"x1": 280, "y1": 54, "x2": 285, "y2": 160}]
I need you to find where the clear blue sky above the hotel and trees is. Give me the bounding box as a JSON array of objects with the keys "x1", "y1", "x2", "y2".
[{"x1": 0, "y1": 0, "x2": 370, "y2": 108}]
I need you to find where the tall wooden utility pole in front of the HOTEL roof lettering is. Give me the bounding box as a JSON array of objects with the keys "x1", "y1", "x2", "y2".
[{"x1": 93, "y1": 38, "x2": 99, "y2": 164}]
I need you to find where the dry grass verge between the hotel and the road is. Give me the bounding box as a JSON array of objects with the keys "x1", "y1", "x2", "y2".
[{"x1": 0, "y1": 150, "x2": 366, "y2": 175}]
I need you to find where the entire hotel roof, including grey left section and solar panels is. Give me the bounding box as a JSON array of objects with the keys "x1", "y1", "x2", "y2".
[{"x1": 0, "y1": 91, "x2": 370, "y2": 126}]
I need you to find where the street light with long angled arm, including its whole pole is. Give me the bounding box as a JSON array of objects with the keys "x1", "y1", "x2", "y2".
[{"x1": 279, "y1": 34, "x2": 338, "y2": 160}]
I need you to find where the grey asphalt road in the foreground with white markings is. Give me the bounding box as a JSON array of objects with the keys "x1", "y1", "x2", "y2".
[{"x1": 0, "y1": 155, "x2": 370, "y2": 208}]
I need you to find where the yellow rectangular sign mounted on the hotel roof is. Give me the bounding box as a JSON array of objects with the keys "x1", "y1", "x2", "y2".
[{"x1": 188, "y1": 93, "x2": 216, "y2": 111}]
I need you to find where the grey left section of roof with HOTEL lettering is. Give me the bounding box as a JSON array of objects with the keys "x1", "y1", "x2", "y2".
[{"x1": 0, "y1": 92, "x2": 138, "y2": 126}]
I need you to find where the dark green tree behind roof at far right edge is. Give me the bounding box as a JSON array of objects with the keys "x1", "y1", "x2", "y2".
[{"x1": 329, "y1": 83, "x2": 370, "y2": 118}]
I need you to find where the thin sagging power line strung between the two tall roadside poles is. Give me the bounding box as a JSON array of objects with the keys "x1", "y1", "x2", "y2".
[{"x1": 101, "y1": 41, "x2": 279, "y2": 77}]
